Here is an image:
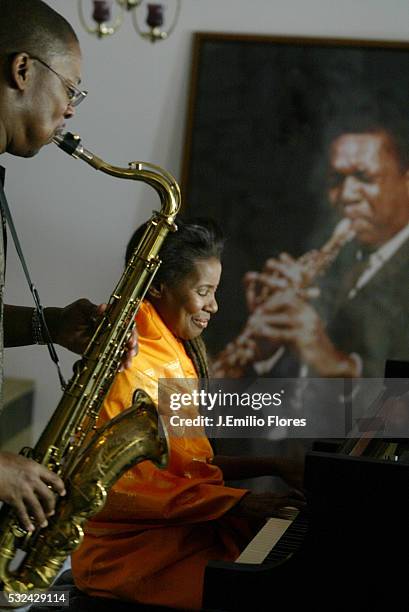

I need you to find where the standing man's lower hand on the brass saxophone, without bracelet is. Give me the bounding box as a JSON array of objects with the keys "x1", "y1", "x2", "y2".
[{"x1": 0, "y1": 452, "x2": 65, "y2": 531}]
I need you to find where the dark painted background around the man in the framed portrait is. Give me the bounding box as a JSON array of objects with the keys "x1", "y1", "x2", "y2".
[{"x1": 182, "y1": 33, "x2": 409, "y2": 378}]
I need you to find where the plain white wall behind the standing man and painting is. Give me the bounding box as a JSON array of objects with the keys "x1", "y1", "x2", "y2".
[{"x1": 2, "y1": 0, "x2": 409, "y2": 434}]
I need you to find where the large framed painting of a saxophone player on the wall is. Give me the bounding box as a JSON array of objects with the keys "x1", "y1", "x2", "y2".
[{"x1": 184, "y1": 34, "x2": 409, "y2": 378}]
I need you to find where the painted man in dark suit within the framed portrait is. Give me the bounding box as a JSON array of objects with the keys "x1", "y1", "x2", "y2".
[{"x1": 215, "y1": 117, "x2": 409, "y2": 377}]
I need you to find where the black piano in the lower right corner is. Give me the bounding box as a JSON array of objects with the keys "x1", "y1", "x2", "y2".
[{"x1": 203, "y1": 362, "x2": 409, "y2": 612}]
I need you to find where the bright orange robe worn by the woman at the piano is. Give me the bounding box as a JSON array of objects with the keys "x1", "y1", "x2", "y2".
[{"x1": 72, "y1": 302, "x2": 252, "y2": 610}]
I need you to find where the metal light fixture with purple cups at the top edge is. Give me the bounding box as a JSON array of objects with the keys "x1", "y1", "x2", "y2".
[{"x1": 78, "y1": 0, "x2": 181, "y2": 42}]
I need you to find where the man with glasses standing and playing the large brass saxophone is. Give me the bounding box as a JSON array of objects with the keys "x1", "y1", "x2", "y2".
[{"x1": 0, "y1": 0, "x2": 136, "y2": 531}]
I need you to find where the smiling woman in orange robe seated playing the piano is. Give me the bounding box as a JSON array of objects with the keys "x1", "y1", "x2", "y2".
[{"x1": 73, "y1": 220, "x2": 303, "y2": 610}]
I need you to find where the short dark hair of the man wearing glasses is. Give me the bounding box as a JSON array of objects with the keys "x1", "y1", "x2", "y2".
[{"x1": 0, "y1": 0, "x2": 78, "y2": 60}]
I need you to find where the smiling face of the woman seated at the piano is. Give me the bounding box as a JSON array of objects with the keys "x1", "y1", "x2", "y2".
[{"x1": 154, "y1": 257, "x2": 222, "y2": 340}]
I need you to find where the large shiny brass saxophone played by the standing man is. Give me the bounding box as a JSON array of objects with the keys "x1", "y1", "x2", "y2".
[{"x1": 0, "y1": 133, "x2": 180, "y2": 605}]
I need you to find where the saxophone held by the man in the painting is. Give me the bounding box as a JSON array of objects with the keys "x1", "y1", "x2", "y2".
[{"x1": 212, "y1": 218, "x2": 355, "y2": 378}]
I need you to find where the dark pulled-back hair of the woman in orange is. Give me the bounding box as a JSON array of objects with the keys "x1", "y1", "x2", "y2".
[{"x1": 125, "y1": 217, "x2": 224, "y2": 287}]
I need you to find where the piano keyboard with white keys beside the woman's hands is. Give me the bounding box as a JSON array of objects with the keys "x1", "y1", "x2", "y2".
[{"x1": 236, "y1": 509, "x2": 308, "y2": 564}]
